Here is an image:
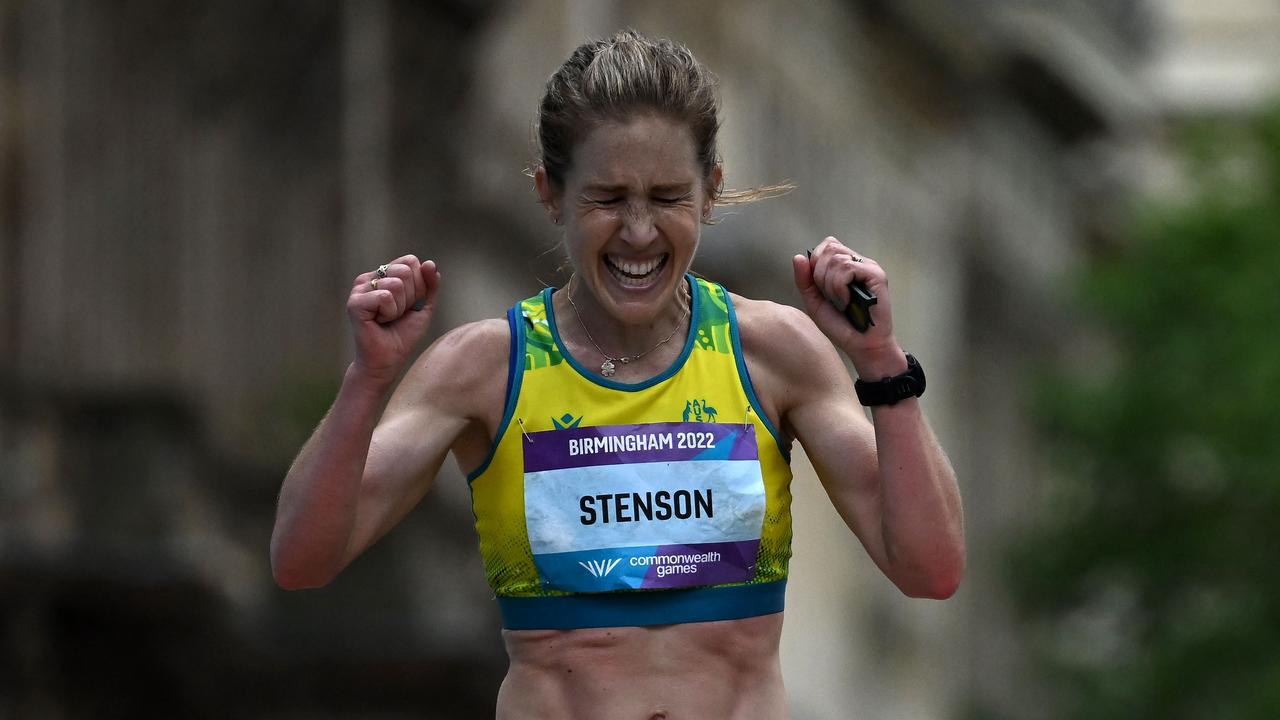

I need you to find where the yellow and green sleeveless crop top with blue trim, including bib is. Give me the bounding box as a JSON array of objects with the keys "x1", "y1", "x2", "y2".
[{"x1": 467, "y1": 275, "x2": 791, "y2": 630}]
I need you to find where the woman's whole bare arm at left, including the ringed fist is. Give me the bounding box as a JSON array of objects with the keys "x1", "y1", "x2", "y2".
[{"x1": 271, "y1": 256, "x2": 507, "y2": 589}]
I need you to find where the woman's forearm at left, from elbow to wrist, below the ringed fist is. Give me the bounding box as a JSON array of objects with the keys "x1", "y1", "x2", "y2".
[{"x1": 271, "y1": 366, "x2": 390, "y2": 589}]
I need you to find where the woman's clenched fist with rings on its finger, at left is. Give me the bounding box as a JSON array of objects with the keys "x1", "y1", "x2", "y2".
[{"x1": 347, "y1": 255, "x2": 440, "y2": 384}]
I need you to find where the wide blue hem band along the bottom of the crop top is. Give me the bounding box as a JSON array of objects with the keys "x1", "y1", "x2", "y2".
[{"x1": 498, "y1": 580, "x2": 787, "y2": 630}]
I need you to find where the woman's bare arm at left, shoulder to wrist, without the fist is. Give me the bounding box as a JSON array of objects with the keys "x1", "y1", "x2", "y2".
[{"x1": 271, "y1": 320, "x2": 508, "y2": 589}]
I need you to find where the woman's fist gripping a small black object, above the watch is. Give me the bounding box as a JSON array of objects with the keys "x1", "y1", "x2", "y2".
[{"x1": 791, "y1": 237, "x2": 906, "y2": 379}]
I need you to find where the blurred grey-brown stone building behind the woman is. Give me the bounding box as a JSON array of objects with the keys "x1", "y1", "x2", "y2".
[{"x1": 0, "y1": 0, "x2": 1280, "y2": 720}]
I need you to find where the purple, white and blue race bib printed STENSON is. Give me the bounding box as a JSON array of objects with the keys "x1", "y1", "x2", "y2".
[{"x1": 524, "y1": 423, "x2": 764, "y2": 592}]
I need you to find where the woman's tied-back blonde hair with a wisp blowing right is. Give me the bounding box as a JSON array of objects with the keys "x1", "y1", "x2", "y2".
[{"x1": 536, "y1": 29, "x2": 795, "y2": 219}]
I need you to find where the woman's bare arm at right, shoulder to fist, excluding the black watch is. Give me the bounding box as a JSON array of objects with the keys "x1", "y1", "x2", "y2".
[{"x1": 741, "y1": 241, "x2": 965, "y2": 598}]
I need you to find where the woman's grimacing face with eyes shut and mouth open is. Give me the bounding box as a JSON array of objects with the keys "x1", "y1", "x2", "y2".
[{"x1": 556, "y1": 115, "x2": 710, "y2": 324}]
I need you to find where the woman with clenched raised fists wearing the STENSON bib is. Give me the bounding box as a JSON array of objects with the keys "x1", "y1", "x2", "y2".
[{"x1": 271, "y1": 32, "x2": 964, "y2": 719}]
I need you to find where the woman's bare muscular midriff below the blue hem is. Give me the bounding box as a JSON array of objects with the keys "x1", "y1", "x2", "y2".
[{"x1": 498, "y1": 612, "x2": 786, "y2": 720}]
